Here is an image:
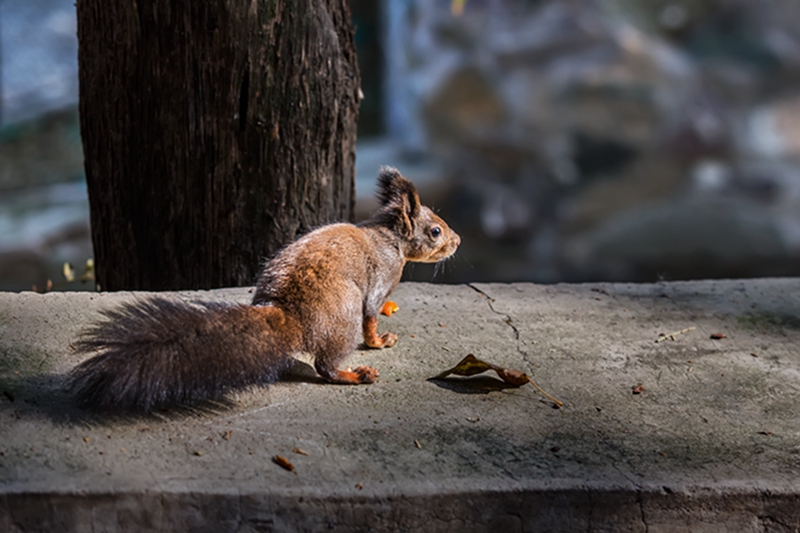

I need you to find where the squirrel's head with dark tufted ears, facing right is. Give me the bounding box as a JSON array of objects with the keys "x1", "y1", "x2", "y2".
[{"x1": 375, "y1": 167, "x2": 461, "y2": 263}]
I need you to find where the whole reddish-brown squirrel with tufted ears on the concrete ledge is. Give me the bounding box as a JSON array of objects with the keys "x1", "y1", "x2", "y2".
[{"x1": 69, "y1": 167, "x2": 461, "y2": 413}]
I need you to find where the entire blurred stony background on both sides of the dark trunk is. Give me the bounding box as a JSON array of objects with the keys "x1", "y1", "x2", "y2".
[{"x1": 0, "y1": 0, "x2": 800, "y2": 290}]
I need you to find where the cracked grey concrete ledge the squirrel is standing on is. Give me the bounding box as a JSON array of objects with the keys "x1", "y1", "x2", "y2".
[{"x1": 0, "y1": 279, "x2": 800, "y2": 532}]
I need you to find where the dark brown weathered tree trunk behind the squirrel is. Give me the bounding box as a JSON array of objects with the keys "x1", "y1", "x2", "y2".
[{"x1": 77, "y1": 0, "x2": 359, "y2": 290}]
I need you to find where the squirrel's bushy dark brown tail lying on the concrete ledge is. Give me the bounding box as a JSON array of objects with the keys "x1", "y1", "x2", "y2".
[{"x1": 70, "y1": 298, "x2": 300, "y2": 412}]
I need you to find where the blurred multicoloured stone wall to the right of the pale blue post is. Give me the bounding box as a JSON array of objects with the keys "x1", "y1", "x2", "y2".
[{"x1": 390, "y1": 0, "x2": 800, "y2": 281}]
